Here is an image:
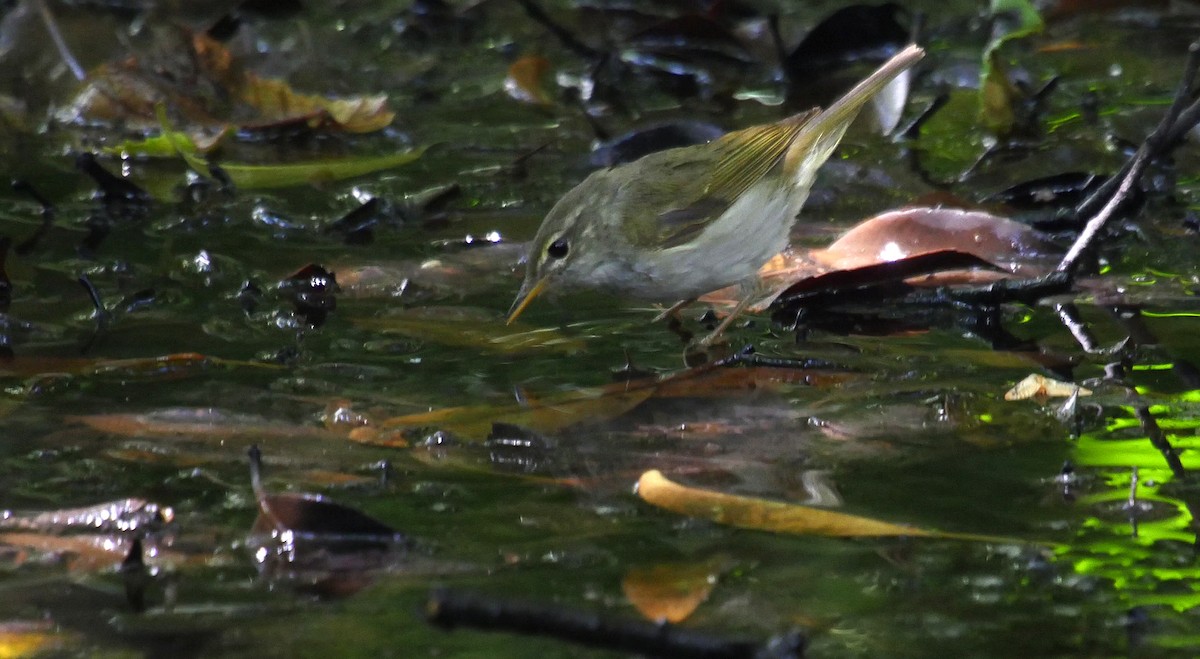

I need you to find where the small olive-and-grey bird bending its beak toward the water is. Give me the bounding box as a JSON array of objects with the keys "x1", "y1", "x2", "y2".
[{"x1": 508, "y1": 46, "x2": 925, "y2": 346}]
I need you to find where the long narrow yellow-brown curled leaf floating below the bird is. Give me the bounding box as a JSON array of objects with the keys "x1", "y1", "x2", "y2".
[{"x1": 637, "y1": 469, "x2": 1021, "y2": 544}]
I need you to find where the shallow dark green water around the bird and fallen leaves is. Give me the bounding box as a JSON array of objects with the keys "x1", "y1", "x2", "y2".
[{"x1": 0, "y1": 2, "x2": 1200, "y2": 657}]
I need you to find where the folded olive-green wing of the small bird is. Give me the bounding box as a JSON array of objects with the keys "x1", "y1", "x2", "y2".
[{"x1": 625, "y1": 109, "x2": 818, "y2": 248}]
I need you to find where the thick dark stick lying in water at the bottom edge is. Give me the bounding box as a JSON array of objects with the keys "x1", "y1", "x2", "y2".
[{"x1": 425, "y1": 589, "x2": 804, "y2": 659}]
